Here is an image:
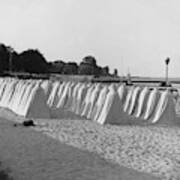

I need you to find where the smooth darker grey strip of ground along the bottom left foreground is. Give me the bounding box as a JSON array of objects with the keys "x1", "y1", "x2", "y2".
[{"x1": 0, "y1": 118, "x2": 158, "y2": 180}]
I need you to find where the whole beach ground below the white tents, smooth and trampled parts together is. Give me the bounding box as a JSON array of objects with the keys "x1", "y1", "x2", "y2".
[{"x1": 0, "y1": 109, "x2": 180, "y2": 180}]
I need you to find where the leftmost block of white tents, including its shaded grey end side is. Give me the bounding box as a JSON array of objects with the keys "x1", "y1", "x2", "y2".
[{"x1": 0, "y1": 78, "x2": 50, "y2": 118}]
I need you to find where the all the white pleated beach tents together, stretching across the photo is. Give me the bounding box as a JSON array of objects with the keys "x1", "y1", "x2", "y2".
[{"x1": 0, "y1": 78, "x2": 176, "y2": 124}]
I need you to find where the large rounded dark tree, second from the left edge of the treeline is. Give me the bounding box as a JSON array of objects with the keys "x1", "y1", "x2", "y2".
[{"x1": 19, "y1": 49, "x2": 48, "y2": 73}]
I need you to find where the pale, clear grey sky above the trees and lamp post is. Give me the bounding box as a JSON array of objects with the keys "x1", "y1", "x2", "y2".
[{"x1": 0, "y1": 0, "x2": 180, "y2": 77}]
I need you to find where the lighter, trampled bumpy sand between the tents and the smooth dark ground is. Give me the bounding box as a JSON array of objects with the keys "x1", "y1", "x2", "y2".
[{"x1": 33, "y1": 120, "x2": 180, "y2": 180}]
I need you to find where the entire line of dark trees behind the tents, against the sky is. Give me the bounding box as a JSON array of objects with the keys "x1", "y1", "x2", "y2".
[{"x1": 0, "y1": 44, "x2": 117, "y2": 76}]
